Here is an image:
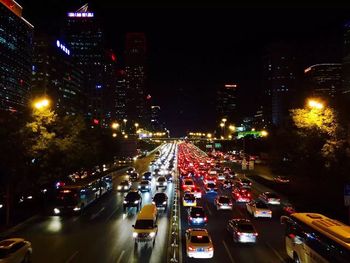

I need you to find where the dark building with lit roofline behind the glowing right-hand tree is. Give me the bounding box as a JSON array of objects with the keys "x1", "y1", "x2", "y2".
[{"x1": 304, "y1": 63, "x2": 342, "y2": 102}]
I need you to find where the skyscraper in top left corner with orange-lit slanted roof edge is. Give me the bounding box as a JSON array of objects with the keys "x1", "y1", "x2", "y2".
[{"x1": 0, "y1": 0, "x2": 33, "y2": 111}]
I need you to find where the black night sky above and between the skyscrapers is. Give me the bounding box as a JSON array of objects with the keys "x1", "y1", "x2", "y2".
[{"x1": 18, "y1": 0, "x2": 350, "y2": 135}]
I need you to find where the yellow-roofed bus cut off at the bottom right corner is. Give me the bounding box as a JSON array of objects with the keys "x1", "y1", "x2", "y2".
[{"x1": 281, "y1": 213, "x2": 350, "y2": 263}]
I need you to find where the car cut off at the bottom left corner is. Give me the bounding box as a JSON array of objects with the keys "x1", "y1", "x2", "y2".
[{"x1": 0, "y1": 238, "x2": 33, "y2": 263}]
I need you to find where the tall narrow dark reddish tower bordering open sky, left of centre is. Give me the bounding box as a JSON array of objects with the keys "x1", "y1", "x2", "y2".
[{"x1": 125, "y1": 33, "x2": 146, "y2": 127}]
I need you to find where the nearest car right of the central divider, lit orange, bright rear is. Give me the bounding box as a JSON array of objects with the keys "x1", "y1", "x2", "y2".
[{"x1": 185, "y1": 228, "x2": 214, "y2": 258}]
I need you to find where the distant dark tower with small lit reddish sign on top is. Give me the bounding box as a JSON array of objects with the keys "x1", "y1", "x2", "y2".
[{"x1": 216, "y1": 83, "x2": 238, "y2": 122}]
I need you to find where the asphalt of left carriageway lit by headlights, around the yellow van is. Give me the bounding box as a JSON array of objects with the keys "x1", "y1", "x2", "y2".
[{"x1": 5, "y1": 155, "x2": 173, "y2": 263}]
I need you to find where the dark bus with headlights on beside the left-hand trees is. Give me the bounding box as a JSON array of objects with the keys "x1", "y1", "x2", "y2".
[{"x1": 53, "y1": 173, "x2": 113, "y2": 215}]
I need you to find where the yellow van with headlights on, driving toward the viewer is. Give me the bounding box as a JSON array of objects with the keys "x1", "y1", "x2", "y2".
[{"x1": 132, "y1": 204, "x2": 158, "y2": 248}]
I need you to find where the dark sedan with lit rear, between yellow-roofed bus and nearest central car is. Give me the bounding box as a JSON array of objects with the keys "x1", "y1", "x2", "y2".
[{"x1": 226, "y1": 218, "x2": 258, "y2": 243}]
